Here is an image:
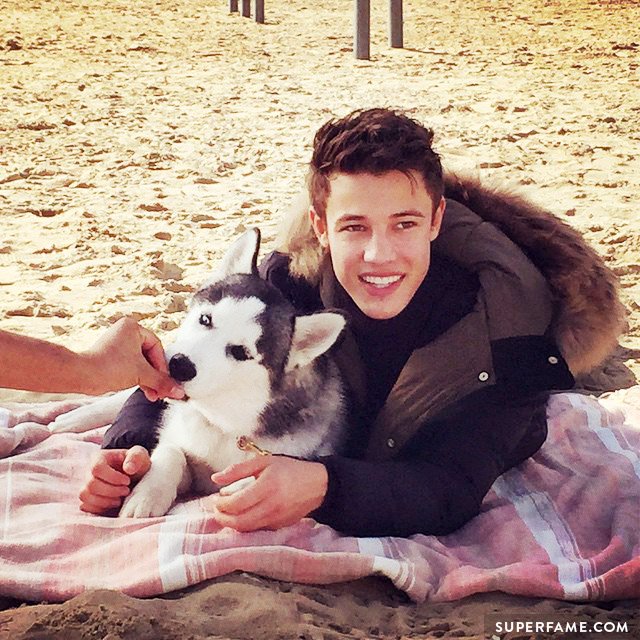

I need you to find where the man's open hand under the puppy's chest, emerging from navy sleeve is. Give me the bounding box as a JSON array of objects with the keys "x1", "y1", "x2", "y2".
[{"x1": 203, "y1": 456, "x2": 328, "y2": 531}]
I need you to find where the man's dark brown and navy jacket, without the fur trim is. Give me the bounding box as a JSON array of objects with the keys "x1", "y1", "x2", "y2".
[{"x1": 105, "y1": 178, "x2": 624, "y2": 535}]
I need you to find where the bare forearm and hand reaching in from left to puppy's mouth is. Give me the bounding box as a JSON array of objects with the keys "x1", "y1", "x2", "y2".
[{"x1": 0, "y1": 318, "x2": 183, "y2": 400}]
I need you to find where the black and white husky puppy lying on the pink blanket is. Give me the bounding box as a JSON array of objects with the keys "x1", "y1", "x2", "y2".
[{"x1": 53, "y1": 229, "x2": 345, "y2": 517}]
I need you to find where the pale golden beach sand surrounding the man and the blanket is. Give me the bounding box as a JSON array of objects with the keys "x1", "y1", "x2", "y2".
[{"x1": 0, "y1": 0, "x2": 640, "y2": 639}]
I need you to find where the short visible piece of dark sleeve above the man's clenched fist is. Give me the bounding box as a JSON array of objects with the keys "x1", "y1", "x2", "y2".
[{"x1": 102, "y1": 389, "x2": 166, "y2": 451}]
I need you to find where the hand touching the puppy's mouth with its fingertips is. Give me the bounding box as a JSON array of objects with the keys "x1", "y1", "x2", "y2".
[{"x1": 85, "y1": 318, "x2": 184, "y2": 402}]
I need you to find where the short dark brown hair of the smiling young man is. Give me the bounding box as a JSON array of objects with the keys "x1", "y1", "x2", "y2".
[{"x1": 308, "y1": 109, "x2": 444, "y2": 217}]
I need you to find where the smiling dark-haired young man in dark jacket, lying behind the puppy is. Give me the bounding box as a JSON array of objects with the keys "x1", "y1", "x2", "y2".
[{"x1": 81, "y1": 109, "x2": 573, "y2": 536}]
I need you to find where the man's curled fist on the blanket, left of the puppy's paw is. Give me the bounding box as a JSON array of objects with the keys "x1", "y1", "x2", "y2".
[{"x1": 80, "y1": 446, "x2": 151, "y2": 515}]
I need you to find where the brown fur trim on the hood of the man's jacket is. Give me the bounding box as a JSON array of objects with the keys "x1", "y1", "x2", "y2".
[{"x1": 278, "y1": 173, "x2": 626, "y2": 375}]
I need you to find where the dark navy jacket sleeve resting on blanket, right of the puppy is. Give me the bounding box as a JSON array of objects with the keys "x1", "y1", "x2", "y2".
[{"x1": 311, "y1": 392, "x2": 547, "y2": 536}]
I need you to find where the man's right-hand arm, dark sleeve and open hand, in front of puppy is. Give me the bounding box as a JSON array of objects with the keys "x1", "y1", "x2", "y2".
[{"x1": 205, "y1": 392, "x2": 547, "y2": 536}]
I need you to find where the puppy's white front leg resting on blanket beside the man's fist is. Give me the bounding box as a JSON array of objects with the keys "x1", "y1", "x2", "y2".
[{"x1": 120, "y1": 444, "x2": 188, "y2": 518}]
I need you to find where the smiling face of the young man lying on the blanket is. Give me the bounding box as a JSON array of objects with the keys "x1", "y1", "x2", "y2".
[{"x1": 310, "y1": 171, "x2": 445, "y2": 320}]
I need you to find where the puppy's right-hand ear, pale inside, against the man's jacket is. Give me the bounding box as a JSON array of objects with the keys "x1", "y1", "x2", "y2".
[{"x1": 285, "y1": 311, "x2": 346, "y2": 371}]
